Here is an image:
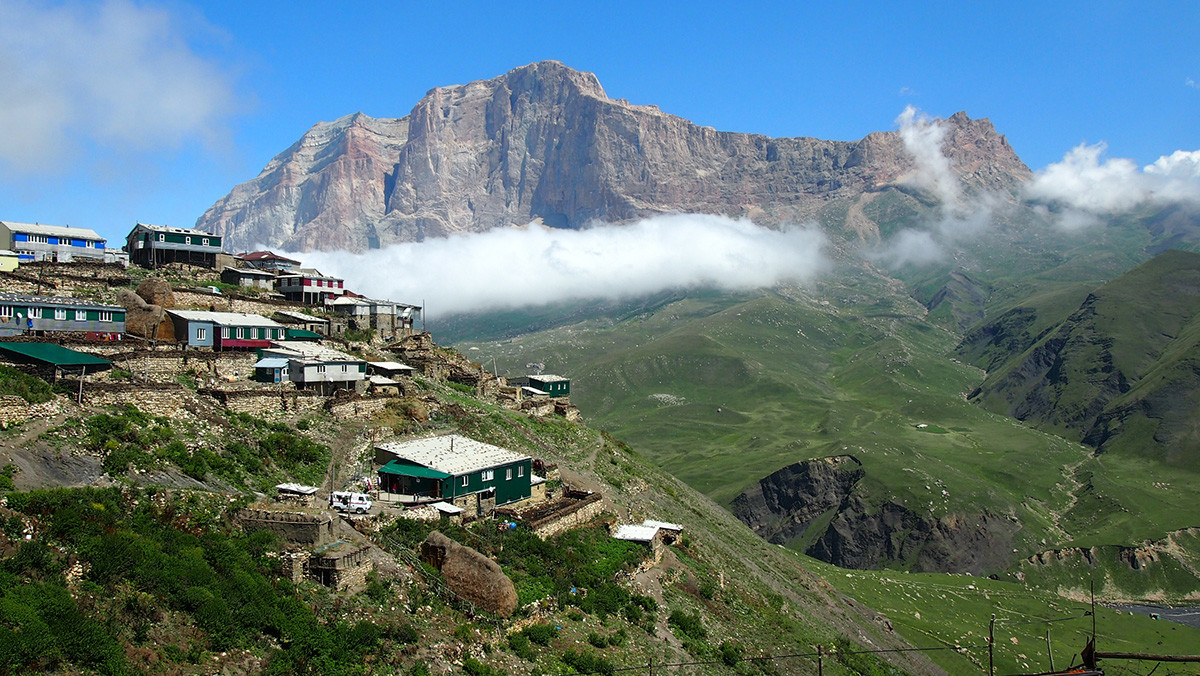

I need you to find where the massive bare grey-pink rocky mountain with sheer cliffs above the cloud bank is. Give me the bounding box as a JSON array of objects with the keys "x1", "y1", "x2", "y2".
[{"x1": 197, "y1": 61, "x2": 1030, "y2": 251}]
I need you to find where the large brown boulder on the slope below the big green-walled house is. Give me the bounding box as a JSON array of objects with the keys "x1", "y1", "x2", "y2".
[{"x1": 421, "y1": 531, "x2": 517, "y2": 617}]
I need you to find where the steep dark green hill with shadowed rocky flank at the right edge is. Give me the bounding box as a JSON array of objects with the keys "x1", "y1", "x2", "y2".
[{"x1": 964, "y1": 251, "x2": 1200, "y2": 471}]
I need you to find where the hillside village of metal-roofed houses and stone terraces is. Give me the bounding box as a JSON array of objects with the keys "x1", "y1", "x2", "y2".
[{"x1": 0, "y1": 221, "x2": 700, "y2": 616}]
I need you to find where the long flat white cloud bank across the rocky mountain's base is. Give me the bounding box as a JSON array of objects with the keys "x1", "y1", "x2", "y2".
[{"x1": 296, "y1": 214, "x2": 828, "y2": 315}]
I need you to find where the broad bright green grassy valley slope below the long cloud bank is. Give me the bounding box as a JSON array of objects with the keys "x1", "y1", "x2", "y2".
[{"x1": 458, "y1": 213, "x2": 1200, "y2": 588}]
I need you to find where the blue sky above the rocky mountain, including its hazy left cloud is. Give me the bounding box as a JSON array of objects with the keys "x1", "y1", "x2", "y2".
[{"x1": 0, "y1": 0, "x2": 1200, "y2": 239}]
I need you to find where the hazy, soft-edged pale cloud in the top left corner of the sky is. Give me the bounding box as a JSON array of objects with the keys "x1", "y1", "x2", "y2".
[{"x1": 0, "y1": 0, "x2": 235, "y2": 174}]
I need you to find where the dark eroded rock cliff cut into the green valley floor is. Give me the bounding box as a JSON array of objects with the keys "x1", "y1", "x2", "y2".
[{"x1": 730, "y1": 455, "x2": 1020, "y2": 574}]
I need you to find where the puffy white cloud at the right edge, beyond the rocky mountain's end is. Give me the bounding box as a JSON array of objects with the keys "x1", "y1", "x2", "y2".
[{"x1": 1025, "y1": 143, "x2": 1200, "y2": 227}]
